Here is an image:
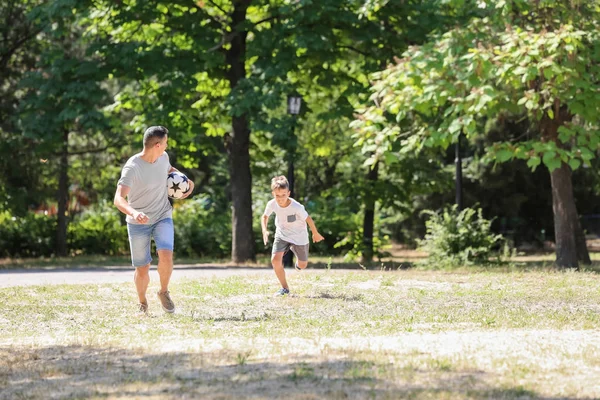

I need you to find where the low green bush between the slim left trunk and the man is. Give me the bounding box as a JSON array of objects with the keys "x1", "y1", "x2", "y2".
[{"x1": 68, "y1": 201, "x2": 129, "y2": 255}]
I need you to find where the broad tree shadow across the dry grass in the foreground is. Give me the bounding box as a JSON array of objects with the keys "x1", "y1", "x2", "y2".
[{"x1": 0, "y1": 346, "x2": 580, "y2": 400}]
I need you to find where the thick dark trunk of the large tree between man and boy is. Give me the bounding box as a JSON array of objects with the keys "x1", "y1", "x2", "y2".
[{"x1": 226, "y1": 0, "x2": 256, "y2": 263}]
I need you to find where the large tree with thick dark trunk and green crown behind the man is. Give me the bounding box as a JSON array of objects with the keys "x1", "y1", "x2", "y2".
[{"x1": 86, "y1": 0, "x2": 422, "y2": 262}]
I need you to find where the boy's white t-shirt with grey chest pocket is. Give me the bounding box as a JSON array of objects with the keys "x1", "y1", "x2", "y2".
[{"x1": 263, "y1": 197, "x2": 308, "y2": 246}]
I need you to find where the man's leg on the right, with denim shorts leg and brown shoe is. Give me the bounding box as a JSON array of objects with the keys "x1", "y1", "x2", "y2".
[{"x1": 153, "y1": 218, "x2": 175, "y2": 312}]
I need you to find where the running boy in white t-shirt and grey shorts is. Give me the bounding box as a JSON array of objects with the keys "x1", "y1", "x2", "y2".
[{"x1": 261, "y1": 176, "x2": 324, "y2": 296}]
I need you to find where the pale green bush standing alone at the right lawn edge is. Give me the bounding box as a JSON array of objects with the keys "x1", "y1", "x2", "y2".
[{"x1": 419, "y1": 205, "x2": 502, "y2": 267}]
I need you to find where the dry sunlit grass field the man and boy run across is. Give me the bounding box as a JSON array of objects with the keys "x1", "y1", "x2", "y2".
[{"x1": 0, "y1": 269, "x2": 600, "y2": 399}]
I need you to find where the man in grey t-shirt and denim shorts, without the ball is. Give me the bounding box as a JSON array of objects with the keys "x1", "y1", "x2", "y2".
[{"x1": 114, "y1": 126, "x2": 194, "y2": 313}]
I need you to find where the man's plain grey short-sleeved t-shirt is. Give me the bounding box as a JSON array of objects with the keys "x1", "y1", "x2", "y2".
[{"x1": 118, "y1": 153, "x2": 173, "y2": 224}]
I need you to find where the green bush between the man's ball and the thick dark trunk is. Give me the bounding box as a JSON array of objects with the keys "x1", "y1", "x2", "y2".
[{"x1": 173, "y1": 196, "x2": 231, "y2": 258}]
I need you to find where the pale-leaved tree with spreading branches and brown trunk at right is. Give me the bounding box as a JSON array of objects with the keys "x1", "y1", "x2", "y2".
[{"x1": 354, "y1": 0, "x2": 600, "y2": 268}]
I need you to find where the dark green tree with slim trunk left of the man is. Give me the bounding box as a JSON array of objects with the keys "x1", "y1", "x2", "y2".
[{"x1": 18, "y1": 4, "x2": 119, "y2": 256}]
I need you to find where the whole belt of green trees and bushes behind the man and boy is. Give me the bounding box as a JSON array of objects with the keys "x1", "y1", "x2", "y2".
[{"x1": 0, "y1": 0, "x2": 600, "y2": 268}]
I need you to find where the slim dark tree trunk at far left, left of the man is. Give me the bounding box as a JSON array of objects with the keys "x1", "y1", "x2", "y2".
[{"x1": 56, "y1": 130, "x2": 69, "y2": 257}]
